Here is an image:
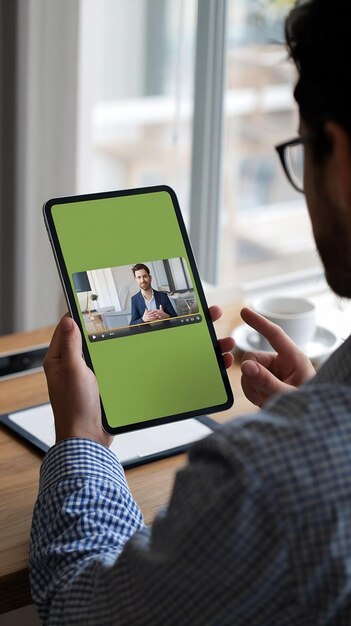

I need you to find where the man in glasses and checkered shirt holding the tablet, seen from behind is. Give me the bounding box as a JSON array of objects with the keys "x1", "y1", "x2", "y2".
[{"x1": 30, "y1": 0, "x2": 351, "y2": 626}]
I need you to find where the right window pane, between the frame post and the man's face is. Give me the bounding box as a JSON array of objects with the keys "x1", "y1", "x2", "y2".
[{"x1": 219, "y1": 0, "x2": 320, "y2": 283}]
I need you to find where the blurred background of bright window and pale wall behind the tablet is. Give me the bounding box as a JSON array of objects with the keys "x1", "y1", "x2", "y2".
[{"x1": 0, "y1": 0, "x2": 326, "y2": 334}]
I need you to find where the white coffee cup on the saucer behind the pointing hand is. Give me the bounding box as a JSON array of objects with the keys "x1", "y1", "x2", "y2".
[{"x1": 252, "y1": 296, "x2": 316, "y2": 350}]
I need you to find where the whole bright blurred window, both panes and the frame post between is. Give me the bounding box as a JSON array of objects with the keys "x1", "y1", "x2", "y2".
[{"x1": 78, "y1": 0, "x2": 320, "y2": 294}]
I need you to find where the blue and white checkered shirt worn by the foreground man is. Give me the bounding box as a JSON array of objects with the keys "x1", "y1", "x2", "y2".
[{"x1": 30, "y1": 339, "x2": 351, "y2": 626}]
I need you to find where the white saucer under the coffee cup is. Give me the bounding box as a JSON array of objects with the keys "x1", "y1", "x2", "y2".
[{"x1": 232, "y1": 324, "x2": 342, "y2": 363}]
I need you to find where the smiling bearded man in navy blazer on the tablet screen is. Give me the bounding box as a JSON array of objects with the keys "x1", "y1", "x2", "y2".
[{"x1": 130, "y1": 263, "x2": 177, "y2": 325}]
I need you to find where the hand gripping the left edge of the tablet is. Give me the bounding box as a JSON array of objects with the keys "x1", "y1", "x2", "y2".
[{"x1": 44, "y1": 317, "x2": 112, "y2": 446}]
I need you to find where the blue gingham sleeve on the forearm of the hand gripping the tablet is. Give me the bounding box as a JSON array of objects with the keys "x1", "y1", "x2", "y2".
[{"x1": 30, "y1": 439, "x2": 144, "y2": 624}]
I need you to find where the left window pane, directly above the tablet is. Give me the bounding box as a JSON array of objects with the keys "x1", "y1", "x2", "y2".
[{"x1": 78, "y1": 0, "x2": 197, "y2": 219}]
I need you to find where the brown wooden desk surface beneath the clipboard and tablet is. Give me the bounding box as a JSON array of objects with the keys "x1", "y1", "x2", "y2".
[{"x1": 0, "y1": 320, "x2": 253, "y2": 613}]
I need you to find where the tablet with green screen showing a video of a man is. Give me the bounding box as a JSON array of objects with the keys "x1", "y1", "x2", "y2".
[{"x1": 43, "y1": 186, "x2": 233, "y2": 434}]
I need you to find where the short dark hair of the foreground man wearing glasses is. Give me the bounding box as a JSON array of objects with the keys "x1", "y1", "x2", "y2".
[{"x1": 285, "y1": 0, "x2": 351, "y2": 157}]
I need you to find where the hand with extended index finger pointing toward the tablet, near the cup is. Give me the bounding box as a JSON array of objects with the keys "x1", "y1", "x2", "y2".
[{"x1": 241, "y1": 307, "x2": 316, "y2": 407}]
